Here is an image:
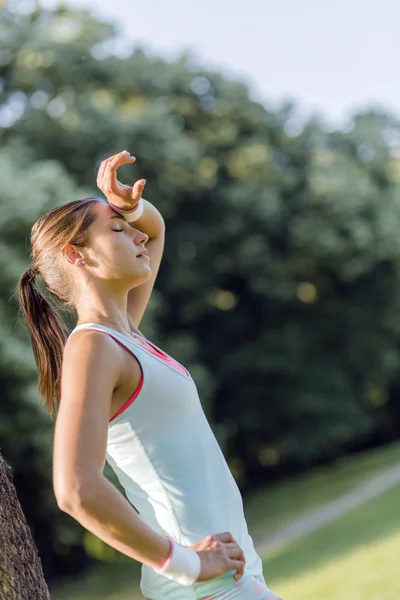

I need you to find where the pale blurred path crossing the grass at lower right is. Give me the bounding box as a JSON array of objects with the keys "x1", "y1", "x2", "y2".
[{"x1": 256, "y1": 465, "x2": 400, "y2": 558}]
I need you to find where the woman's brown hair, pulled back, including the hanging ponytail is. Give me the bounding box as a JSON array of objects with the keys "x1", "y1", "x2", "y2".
[{"x1": 18, "y1": 198, "x2": 102, "y2": 414}]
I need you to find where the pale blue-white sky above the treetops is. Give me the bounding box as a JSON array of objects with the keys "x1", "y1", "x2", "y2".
[{"x1": 40, "y1": 0, "x2": 400, "y2": 126}]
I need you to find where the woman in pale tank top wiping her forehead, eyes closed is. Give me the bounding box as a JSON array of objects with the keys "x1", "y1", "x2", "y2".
[{"x1": 19, "y1": 151, "x2": 277, "y2": 600}]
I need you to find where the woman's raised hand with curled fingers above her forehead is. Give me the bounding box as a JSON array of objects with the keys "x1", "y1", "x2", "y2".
[{"x1": 96, "y1": 150, "x2": 146, "y2": 210}]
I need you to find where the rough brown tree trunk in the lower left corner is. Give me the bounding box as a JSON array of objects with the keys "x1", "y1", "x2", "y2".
[{"x1": 0, "y1": 453, "x2": 50, "y2": 600}]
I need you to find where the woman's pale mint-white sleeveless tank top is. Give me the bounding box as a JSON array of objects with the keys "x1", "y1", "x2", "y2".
[{"x1": 69, "y1": 323, "x2": 262, "y2": 600}]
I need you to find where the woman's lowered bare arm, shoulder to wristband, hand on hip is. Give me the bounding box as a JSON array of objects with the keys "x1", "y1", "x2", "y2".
[{"x1": 53, "y1": 331, "x2": 169, "y2": 568}]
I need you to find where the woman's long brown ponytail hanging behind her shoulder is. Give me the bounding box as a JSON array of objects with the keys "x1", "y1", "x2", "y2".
[{"x1": 18, "y1": 265, "x2": 68, "y2": 415}]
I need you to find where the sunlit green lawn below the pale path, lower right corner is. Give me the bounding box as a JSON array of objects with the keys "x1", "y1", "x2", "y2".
[{"x1": 264, "y1": 485, "x2": 400, "y2": 600}]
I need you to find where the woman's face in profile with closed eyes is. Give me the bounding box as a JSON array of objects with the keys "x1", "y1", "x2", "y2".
[{"x1": 81, "y1": 203, "x2": 151, "y2": 287}]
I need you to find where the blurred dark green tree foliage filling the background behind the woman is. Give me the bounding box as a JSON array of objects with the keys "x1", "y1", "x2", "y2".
[{"x1": 0, "y1": 4, "x2": 400, "y2": 580}]
